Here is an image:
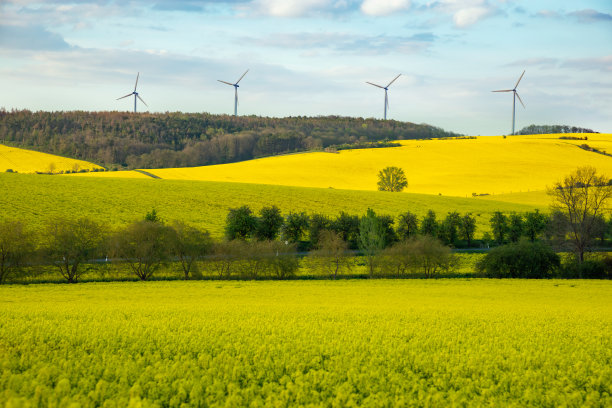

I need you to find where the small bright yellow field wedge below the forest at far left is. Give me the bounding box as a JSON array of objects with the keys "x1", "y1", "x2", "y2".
[{"x1": 0, "y1": 144, "x2": 102, "y2": 173}]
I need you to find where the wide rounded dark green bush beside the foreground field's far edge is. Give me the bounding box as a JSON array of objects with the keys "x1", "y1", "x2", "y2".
[{"x1": 476, "y1": 241, "x2": 561, "y2": 279}]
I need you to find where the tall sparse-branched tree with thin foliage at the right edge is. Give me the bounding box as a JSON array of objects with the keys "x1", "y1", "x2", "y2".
[{"x1": 548, "y1": 166, "x2": 612, "y2": 263}]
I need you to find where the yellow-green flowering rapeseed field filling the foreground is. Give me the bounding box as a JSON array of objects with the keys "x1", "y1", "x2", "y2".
[{"x1": 0, "y1": 280, "x2": 612, "y2": 407}]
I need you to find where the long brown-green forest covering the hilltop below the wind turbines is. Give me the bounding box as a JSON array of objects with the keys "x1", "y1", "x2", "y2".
[{"x1": 0, "y1": 109, "x2": 458, "y2": 170}]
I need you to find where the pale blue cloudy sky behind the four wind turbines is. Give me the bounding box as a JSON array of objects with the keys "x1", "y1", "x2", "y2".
[{"x1": 0, "y1": 0, "x2": 612, "y2": 135}]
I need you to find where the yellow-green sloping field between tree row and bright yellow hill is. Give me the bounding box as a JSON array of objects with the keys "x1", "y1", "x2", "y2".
[{"x1": 0, "y1": 173, "x2": 545, "y2": 236}]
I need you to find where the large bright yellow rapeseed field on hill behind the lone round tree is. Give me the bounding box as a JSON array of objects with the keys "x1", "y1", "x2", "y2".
[{"x1": 124, "y1": 134, "x2": 612, "y2": 197}]
